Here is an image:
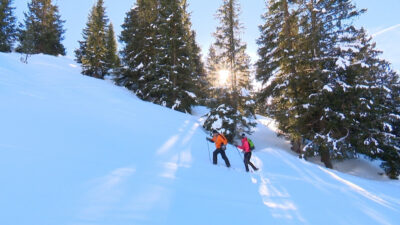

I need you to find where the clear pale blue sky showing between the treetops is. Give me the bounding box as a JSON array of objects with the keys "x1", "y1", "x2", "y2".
[{"x1": 14, "y1": 0, "x2": 400, "y2": 71}]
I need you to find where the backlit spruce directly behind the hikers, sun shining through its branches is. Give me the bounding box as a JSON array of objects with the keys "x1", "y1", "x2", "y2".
[{"x1": 205, "y1": 0, "x2": 255, "y2": 141}]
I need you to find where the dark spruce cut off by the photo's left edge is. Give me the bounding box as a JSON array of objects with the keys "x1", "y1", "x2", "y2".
[{"x1": 0, "y1": 0, "x2": 17, "y2": 52}]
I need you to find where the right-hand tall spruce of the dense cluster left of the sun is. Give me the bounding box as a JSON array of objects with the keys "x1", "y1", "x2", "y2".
[{"x1": 145, "y1": 0, "x2": 196, "y2": 113}]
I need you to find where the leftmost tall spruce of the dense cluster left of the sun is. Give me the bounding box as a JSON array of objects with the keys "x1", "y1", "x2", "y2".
[{"x1": 116, "y1": 0, "x2": 158, "y2": 92}]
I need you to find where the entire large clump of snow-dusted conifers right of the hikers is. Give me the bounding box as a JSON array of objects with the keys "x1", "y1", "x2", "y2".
[{"x1": 256, "y1": 0, "x2": 400, "y2": 178}]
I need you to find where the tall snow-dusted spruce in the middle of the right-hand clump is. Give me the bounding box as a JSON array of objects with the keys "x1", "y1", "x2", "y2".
[{"x1": 298, "y1": 0, "x2": 376, "y2": 168}]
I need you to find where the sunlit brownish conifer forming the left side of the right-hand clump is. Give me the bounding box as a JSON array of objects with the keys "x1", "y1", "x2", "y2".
[{"x1": 256, "y1": 0, "x2": 304, "y2": 151}]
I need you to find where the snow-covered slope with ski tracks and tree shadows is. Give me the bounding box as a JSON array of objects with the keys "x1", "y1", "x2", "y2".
[{"x1": 0, "y1": 54, "x2": 400, "y2": 225}]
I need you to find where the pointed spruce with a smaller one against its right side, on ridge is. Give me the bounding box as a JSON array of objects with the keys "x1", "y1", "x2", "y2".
[{"x1": 75, "y1": 0, "x2": 119, "y2": 79}]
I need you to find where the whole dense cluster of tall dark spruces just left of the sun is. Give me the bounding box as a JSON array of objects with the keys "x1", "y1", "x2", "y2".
[{"x1": 117, "y1": 0, "x2": 203, "y2": 112}]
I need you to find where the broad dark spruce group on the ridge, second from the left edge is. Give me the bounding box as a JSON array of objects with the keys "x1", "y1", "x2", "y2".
[{"x1": 16, "y1": 0, "x2": 65, "y2": 55}]
